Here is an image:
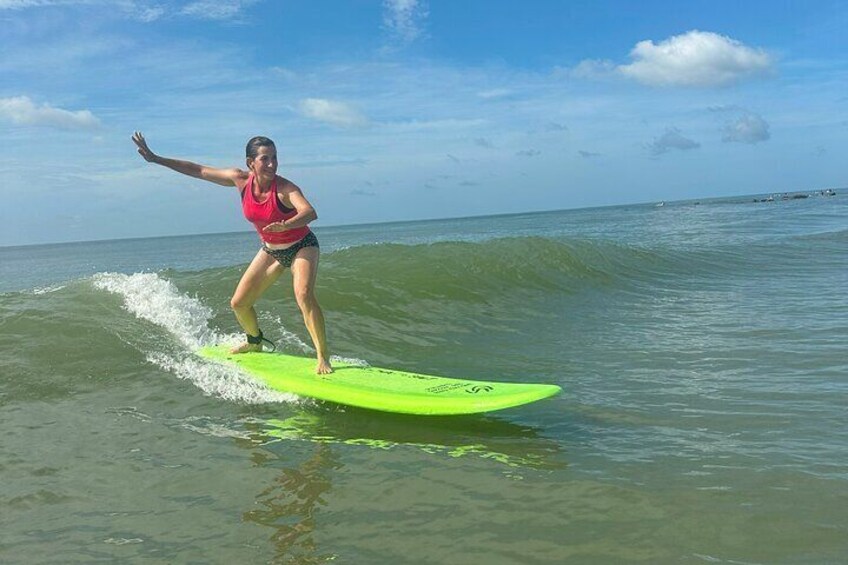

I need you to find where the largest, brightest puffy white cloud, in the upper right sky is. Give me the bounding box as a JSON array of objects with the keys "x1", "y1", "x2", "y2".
[{"x1": 616, "y1": 30, "x2": 772, "y2": 86}]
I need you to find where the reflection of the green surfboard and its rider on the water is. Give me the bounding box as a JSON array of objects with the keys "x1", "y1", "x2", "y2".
[{"x1": 240, "y1": 409, "x2": 567, "y2": 565}]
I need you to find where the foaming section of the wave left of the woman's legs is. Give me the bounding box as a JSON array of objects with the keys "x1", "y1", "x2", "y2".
[{"x1": 0, "y1": 273, "x2": 304, "y2": 403}]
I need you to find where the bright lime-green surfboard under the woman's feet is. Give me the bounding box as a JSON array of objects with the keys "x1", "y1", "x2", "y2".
[{"x1": 198, "y1": 345, "x2": 562, "y2": 416}]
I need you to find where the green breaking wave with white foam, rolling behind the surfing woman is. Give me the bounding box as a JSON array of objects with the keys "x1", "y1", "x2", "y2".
[{"x1": 0, "y1": 237, "x2": 673, "y2": 396}]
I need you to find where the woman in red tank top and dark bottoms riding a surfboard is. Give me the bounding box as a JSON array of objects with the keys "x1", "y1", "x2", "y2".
[{"x1": 132, "y1": 132, "x2": 333, "y2": 375}]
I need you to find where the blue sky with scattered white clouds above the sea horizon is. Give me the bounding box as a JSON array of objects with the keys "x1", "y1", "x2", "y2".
[{"x1": 0, "y1": 0, "x2": 848, "y2": 246}]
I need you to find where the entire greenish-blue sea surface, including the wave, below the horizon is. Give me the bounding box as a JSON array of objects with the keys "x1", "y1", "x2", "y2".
[{"x1": 0, "y1": 190, "x2": 848, "y2": 565}]
